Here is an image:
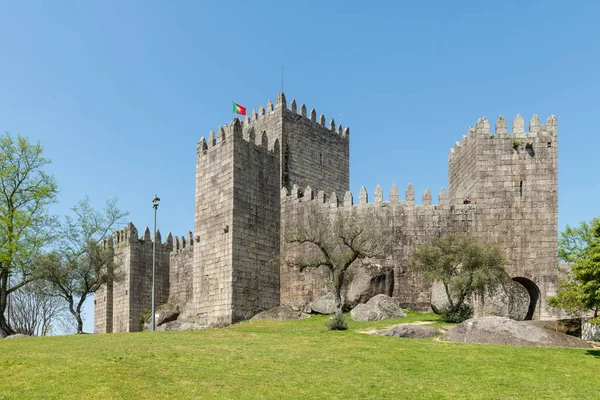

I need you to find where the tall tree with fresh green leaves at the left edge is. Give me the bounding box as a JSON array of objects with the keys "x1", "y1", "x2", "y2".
[{"x1": 0, "y1": 133, "x2": 57, "y2": 337}]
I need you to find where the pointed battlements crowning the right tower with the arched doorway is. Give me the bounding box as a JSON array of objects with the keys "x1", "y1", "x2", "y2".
[{"x1": 448, "y1": 114, "x2": 557, "y2": 160}]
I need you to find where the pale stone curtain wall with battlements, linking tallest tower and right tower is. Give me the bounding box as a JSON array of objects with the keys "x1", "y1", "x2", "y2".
[{"x1": 281, "y1": 184, "x2": 475, "y2": 310}]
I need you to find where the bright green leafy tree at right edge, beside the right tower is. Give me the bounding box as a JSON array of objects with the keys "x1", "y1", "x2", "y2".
[{"x1": 548, "y1": 218, "x2": 600, "y2": 324}]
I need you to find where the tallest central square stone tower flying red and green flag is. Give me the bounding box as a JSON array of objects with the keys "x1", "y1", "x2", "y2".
[{"x1": 187, "y1": 93, "x2": 349, "y2": 325}]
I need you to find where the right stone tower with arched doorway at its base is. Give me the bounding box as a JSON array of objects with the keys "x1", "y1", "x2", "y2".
[{"x1": 448, "y1": 115, "x2": 558, "y2": 318}]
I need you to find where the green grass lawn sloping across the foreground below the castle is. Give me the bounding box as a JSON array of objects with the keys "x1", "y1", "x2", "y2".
[{"x1": 0, "y1": 313, "x2": 600, "y2": 399}]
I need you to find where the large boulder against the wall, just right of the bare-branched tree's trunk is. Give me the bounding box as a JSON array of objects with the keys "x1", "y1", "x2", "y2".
[{"x1": 342, "y1": 264, "x2": 394, "y2": 310}]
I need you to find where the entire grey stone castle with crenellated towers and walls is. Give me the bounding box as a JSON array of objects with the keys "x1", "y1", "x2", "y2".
[{"x1": 94, "y1": 93, "x2": 558, "y2": 333}]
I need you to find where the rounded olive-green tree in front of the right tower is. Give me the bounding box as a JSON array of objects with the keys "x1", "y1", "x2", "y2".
[{"x1": 409, "y1": 233, "x2": 510, "y2": 322}]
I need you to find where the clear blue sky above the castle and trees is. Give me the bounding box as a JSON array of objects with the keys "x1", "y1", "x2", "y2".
[{"x1": 0, "y1": 0, "x2": 600, "y2": 331}]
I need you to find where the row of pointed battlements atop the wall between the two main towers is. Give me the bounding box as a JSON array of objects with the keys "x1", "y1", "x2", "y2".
[{"x1": 281, "y1": 183, "x2": 454, "y2": 208}]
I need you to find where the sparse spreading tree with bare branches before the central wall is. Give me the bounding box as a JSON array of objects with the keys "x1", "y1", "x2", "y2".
[{"x1": 284, "y1": 202, "x2": 391, "y2": 330}]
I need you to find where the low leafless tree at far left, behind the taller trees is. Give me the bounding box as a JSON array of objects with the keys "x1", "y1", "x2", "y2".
[{"x1": 7, "y1": 280, "x2": 73, "y2": 336}]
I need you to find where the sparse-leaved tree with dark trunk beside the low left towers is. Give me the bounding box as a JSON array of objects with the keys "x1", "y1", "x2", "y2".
[{"x1": 40, "y1": 198, "x2": 128, "y2": 333}]
